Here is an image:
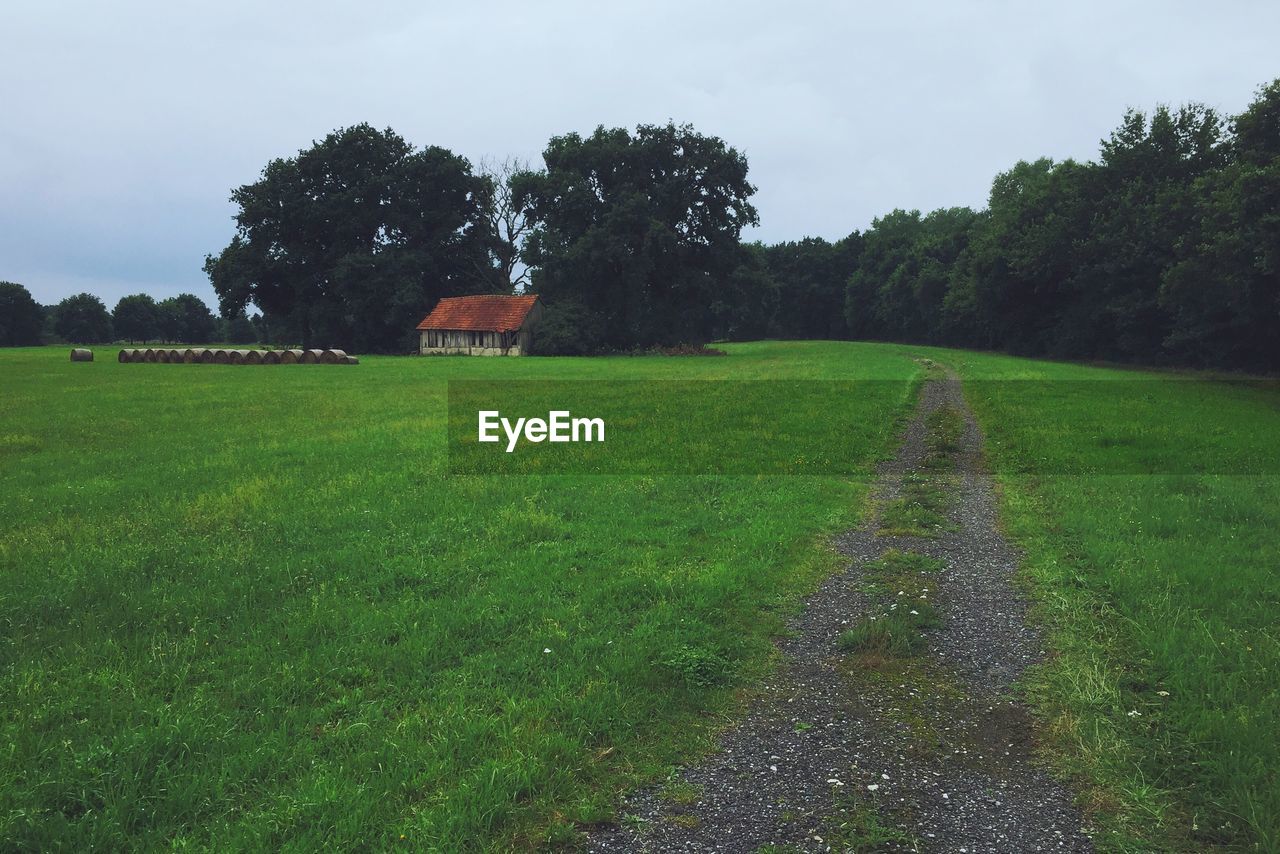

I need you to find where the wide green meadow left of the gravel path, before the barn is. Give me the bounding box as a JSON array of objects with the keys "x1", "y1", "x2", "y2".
[{"x1": 0, "y1": 343, "x2": 918, "y2": 850}]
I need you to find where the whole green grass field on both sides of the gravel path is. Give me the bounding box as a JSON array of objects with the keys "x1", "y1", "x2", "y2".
[{"x1": 0, "y1": 343, "x2": 1280, "y2": 850}]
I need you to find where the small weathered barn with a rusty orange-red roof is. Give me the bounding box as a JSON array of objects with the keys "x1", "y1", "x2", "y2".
[{"x1": 417, "y1": 293, "x2": 543, "y2": 356}]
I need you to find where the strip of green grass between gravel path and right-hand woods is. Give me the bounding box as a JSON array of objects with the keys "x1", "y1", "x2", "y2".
[{"x1": 936, "y1": 351, "x2": 1280, "y2": 850}]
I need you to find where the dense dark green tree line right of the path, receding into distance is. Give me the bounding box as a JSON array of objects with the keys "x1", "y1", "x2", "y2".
[{"x1": 717, "y1": 81, "x2": 1280, "y2": 371}]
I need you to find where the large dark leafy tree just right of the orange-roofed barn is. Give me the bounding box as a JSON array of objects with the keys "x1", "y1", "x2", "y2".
[{"x1": 512, "y1": 123, "x2": 759, "y2": 348}]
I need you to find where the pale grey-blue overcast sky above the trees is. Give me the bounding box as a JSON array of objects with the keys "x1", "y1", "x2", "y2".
[{"x1": 0, "y1": 0, "x2": 1280, "y2": 307}]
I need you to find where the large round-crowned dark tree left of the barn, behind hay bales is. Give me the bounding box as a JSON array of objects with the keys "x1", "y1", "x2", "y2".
[{"x1": 205, "y1": 124, "x2": 497, "y2": 351}]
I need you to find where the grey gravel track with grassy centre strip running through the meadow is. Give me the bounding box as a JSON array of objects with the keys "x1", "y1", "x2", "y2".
[{"x1": 588, "y1": 378, "x2": 1092, "y2": 854}]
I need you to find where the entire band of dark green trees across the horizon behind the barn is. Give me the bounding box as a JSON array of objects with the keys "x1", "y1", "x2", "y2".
[{"x1": 0, "y1": 81, "x2": 1280, "y2": 370}]
